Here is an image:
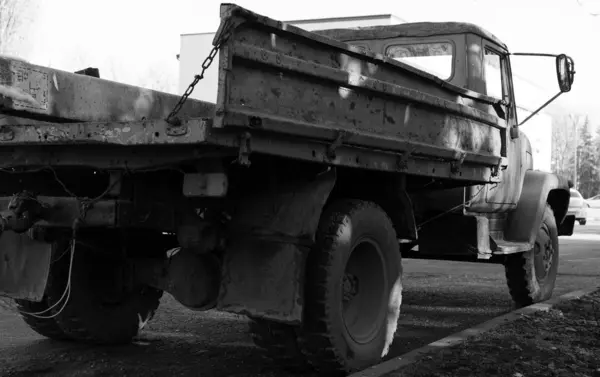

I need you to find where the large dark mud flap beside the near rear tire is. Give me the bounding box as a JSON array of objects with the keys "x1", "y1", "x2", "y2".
[{"x1": 217, "y1": 169, "x2": 336, "y2": 324}]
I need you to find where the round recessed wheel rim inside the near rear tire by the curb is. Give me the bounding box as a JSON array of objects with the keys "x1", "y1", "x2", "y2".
[{"x1": 342, "y1": 238, "x2": 387, "y2": 344}]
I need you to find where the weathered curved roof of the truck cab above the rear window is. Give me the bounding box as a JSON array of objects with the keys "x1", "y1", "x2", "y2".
[{"x1": 313, "y1": 22, "x2": 507, "y2": 49}]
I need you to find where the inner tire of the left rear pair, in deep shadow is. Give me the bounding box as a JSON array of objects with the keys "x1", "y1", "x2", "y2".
[{"x1": 47, "y1": 240, "x2": 162, "y2": 345}]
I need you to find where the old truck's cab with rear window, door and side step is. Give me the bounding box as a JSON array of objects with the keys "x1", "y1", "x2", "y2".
[{"x1": 316, "y1": 22, "x2": 572, "y2": 259}]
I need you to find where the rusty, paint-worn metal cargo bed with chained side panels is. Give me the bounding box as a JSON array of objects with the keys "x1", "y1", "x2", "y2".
[{"x1": 0, "y1": 5, "x2": 507, "y2": 182}]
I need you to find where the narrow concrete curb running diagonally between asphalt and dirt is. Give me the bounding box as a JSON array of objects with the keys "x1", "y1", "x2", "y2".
[{"x1": 347, "y1": 287, "x2": 600, "y2": 377}]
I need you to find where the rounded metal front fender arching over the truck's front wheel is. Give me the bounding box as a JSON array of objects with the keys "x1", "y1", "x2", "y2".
[{"x1": 504, "y1": 170, "x2": 570, "y2": 246}]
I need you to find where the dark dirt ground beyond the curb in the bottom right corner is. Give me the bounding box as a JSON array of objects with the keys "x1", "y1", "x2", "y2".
[{"x1": 386, "y1": 289, "x2": 600, "y2": 377}]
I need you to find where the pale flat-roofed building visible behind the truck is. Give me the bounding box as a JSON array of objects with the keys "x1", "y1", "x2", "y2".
[{"x1": 178, "y1": 14, "x2": 555, "y2": 172}]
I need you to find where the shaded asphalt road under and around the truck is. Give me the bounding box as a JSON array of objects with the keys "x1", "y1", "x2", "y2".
[{"x1": 0, "y1": 223, "x2": 600, "y2": 377}]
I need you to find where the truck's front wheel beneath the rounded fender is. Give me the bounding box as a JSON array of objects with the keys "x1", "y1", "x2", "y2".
[{"x1": 504, "y1": 205, "x2": 559, "y2": 307}]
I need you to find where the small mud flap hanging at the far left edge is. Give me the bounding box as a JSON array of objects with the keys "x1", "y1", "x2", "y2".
[{"x1": 0, "y1": 232, "x2": 52, "y2": 301}]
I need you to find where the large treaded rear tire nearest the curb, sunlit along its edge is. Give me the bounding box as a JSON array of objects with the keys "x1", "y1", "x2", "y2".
[{"x1": 299, "y1": 200, "x2": 402, "y2": 375}]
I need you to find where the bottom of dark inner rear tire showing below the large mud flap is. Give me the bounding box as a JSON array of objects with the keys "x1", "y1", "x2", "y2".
[{"x1": 249, "y1": 318, "x2": 309, "y2": 372}]
